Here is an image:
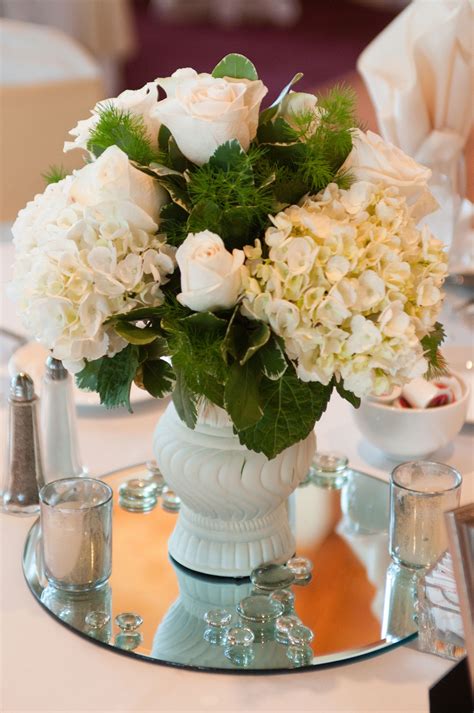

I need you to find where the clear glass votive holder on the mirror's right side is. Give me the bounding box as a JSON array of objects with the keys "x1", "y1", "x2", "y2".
[{"x1": 389, "y1": 461, "x2": 462, "y2": 568}]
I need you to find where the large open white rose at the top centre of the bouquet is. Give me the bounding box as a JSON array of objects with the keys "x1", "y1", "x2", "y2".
[{"x1": 153, "y1": 69, "x2": 267, "y2": 165}]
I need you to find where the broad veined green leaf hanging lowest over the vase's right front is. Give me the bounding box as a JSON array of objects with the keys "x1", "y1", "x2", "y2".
[{"x1": 237, "y1": 369, "x2": 332, "y2": 458}]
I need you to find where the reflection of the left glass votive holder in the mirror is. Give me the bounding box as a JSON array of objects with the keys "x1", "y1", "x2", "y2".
[{"x1": 41, "y1": 584, "x2": 112, "y2": 643}]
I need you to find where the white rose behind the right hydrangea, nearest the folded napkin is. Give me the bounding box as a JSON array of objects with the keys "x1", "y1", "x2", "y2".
[{"x1": 341, "y1": 129, "x2": 438, "y2": 219}]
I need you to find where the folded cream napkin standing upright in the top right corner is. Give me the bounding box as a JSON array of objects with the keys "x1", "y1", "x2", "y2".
[{"x1": 358, "y1": 0, "x2": 474, "y2": 250}]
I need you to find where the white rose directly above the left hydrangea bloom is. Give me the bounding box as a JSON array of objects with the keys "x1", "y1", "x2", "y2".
[{"x1": 70, "y1": 146, "x2": 167, "y2": 222}]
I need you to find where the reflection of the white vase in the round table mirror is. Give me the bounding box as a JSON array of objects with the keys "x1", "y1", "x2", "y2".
[{"x1": 152, "y1": 561, "x2": 291, "y2": 669}]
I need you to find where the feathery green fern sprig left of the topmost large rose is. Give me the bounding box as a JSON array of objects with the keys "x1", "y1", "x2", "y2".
[{"x1": 87, "y1": 104, "x2": 162, "y2": 166}]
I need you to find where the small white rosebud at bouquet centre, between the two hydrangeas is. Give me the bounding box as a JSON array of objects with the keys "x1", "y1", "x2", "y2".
[{"x1": 176, "y1": 230, "x2": 245, "y2": 312}]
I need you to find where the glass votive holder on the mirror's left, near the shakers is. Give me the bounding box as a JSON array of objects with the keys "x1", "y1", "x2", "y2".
[{"x1": 40, "y1": 477, "x2": 113, "y2": 591}]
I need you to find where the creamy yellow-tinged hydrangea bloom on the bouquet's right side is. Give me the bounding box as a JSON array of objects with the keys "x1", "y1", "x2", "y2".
[{"x1": 242, "y1": 181, "x2": 447, "y2": 396}]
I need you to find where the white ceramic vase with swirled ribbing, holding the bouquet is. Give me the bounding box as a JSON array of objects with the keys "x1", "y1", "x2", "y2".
[{"x1": 153, "y1": 403, "x2": 316, "y2": 577}]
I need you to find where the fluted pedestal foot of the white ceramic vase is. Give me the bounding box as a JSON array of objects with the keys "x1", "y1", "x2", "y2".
[{"x1": 168, "y1": 502, "x2": 295, "y2": 577}]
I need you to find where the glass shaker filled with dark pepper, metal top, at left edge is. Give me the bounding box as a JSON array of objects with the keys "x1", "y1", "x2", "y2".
[{"x1": 0, "y1": 372, "x2": 44, "y2": 515}]
